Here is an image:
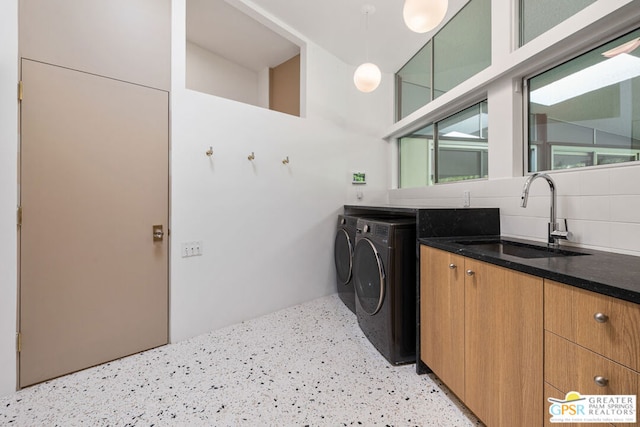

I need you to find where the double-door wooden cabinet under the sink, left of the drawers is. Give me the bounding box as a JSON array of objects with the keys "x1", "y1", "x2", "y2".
[{"x1": 420, "y1": 247, "x2": 543, "y2": 426}]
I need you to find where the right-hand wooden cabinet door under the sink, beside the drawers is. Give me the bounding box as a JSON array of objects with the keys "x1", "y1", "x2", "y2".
[{"x1": 465, "y1": 259, "x2": 543, "y2": 427}]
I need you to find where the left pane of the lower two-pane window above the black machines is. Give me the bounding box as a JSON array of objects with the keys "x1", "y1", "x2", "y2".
[{"x1": 398, "y1": 125, "x2": 434, "y2": 188}]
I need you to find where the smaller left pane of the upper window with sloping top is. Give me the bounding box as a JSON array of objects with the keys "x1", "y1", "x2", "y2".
[{"x1": 396, "y1": 42, "x2": 431, "y2": 120}]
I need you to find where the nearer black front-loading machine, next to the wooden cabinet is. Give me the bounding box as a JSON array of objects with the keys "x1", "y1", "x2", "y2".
[{"x1": 353, "y1": 218, "x2": 417, "y2": 365}]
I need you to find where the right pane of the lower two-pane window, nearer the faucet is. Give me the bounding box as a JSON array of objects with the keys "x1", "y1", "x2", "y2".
[{"x1": 436, "y1": 101, "x2": 489, "y2": 183}]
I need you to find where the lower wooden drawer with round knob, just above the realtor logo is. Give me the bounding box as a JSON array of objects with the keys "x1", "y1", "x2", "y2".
[{"x1": 544, "y1": 331, "x2": 638, "y2": 402}]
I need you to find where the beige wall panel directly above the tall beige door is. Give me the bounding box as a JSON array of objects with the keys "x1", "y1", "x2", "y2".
[{"x1": 18, "y1": 0, "x2": 171, "y2": 90}]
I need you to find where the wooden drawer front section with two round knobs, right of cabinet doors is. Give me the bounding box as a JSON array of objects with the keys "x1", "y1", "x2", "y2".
[{"x1": 544, "y1": 280, "x2": 640, "y2": 426}]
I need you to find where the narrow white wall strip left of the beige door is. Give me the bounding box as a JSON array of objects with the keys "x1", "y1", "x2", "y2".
[{"x1": 0, "y1": 0, "x2": 18, "y2": 395}]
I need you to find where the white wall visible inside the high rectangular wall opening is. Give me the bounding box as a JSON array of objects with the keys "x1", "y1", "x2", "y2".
[{"x1": 186, "y1": 42, "x2": 269, "y2": 108}]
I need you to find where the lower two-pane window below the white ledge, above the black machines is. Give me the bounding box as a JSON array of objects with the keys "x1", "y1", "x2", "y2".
[{"x1": 398, "y1": 101, "x2": 489, "y2": 188}]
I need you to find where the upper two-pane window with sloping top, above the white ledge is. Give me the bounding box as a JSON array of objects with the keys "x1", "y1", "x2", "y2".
[{"x1": 396, "y1": 0, "x2": 491, "y2": 120}]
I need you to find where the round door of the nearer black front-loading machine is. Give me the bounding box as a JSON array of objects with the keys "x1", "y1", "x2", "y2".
[{"x1": 353, "y1": 238, "x2": 385, "y2": 316}]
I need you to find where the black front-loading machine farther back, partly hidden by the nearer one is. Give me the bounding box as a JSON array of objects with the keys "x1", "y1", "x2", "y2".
[{"x1": 333, "y1": 215, "x2": 358, "y2": 313}]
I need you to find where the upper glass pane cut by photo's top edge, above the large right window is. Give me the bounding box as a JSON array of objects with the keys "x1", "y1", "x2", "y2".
[{"x1": 520, "y1": 0, "x2": 596, "y2": 46}]
